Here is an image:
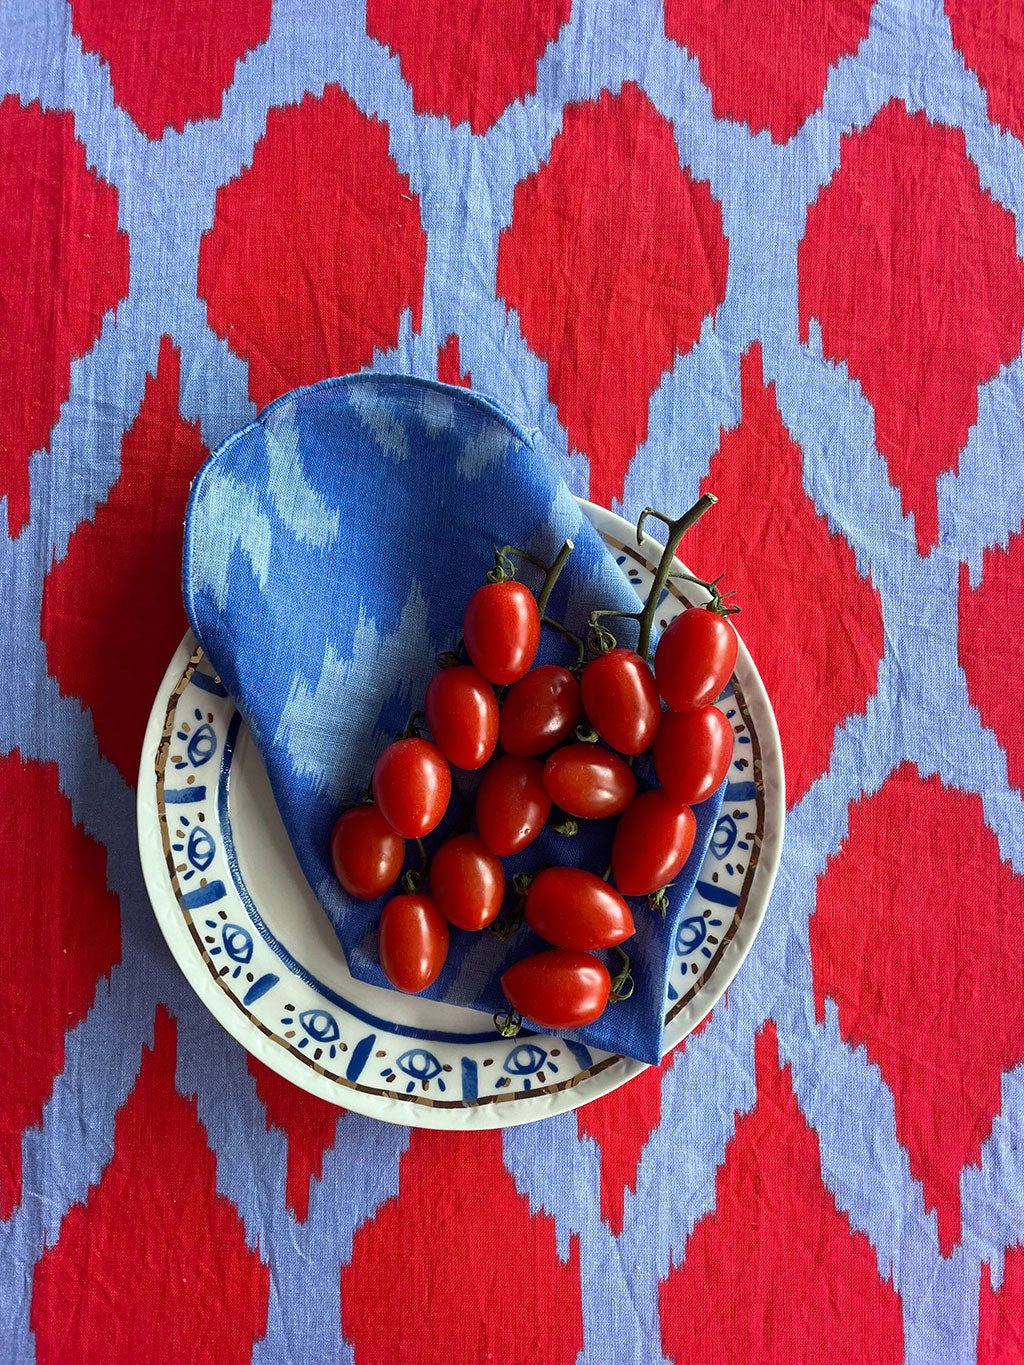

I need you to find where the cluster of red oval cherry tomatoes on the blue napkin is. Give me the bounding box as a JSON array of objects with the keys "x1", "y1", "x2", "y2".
[{"x1": 330, "y1": 542, "x2": 737, "y2": 1031}]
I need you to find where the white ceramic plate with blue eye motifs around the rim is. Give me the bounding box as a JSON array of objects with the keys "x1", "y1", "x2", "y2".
[{"x1": 138, "y1": 502, "x2": 785, "y2": 1127}]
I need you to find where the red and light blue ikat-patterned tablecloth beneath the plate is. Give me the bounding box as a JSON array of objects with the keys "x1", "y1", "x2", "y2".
[{"x1": 0, "y1": 0, "x2": 1024, "y2": 1365}]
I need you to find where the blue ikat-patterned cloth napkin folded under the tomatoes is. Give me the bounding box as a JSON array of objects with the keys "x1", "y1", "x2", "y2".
[{"x1": 183, "y1": 374, "x2": 721, "y2": 1062}]
